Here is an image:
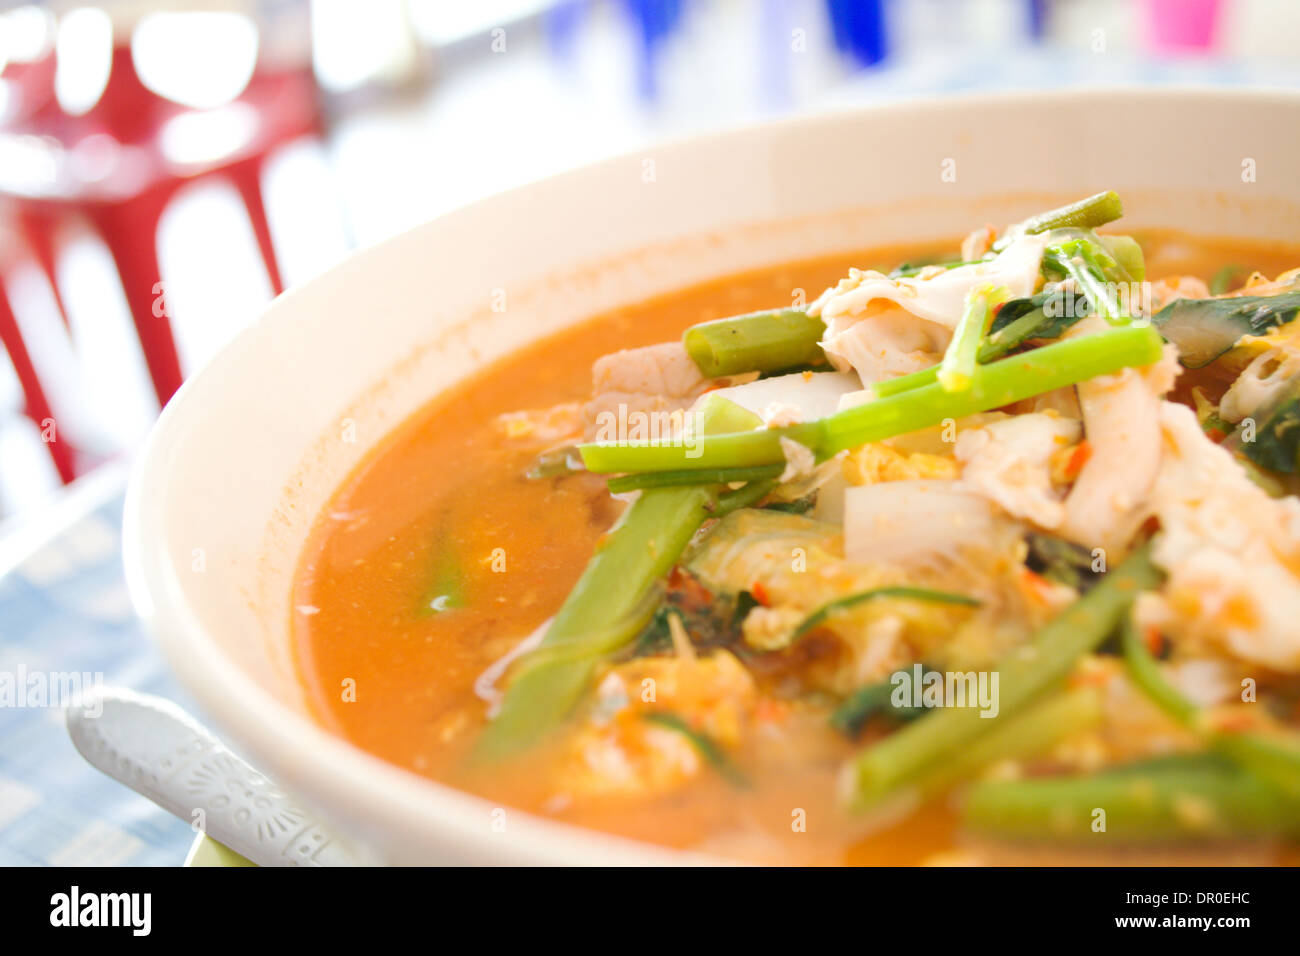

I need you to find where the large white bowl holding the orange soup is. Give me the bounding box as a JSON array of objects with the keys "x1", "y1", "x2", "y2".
[{"x1": 125, "y1": 90, "x2": 1300, "y2": 864}]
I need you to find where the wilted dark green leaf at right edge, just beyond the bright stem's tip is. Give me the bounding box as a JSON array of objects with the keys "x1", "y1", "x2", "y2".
[{"x1": 1152, "y1": 291, "x2": 1300, "y2": 368}]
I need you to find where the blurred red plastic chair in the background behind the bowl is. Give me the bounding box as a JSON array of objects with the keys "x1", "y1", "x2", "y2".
[{"x1": 0, "y1": 33, "x2": 322, "y2": 480}]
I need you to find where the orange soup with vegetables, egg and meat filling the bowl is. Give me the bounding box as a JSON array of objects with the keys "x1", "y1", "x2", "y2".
[{"x1": 293, "y1": 196, "x2": 1300, "y2": 864}]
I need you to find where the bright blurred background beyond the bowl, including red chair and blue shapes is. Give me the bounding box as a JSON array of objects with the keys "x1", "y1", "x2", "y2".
[{"x1": 0, "y1": 0, "x2": 1300, "y2": 530}]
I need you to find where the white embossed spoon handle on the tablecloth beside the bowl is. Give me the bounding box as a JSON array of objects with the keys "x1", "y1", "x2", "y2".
[{"x1": 66, "y1": 687, "x2": 354, "y2": 866}]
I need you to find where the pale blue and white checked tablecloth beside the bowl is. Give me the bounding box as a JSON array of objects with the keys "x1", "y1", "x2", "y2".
[{"x1": 0, "y1": 473, "x2": 194, "y2": 866}]
